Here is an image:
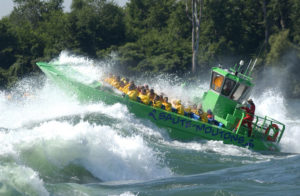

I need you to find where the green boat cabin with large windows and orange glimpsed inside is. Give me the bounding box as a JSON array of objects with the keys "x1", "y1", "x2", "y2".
[{"x1": 202, "y1": 62, "x2": 254, "y2": 121}]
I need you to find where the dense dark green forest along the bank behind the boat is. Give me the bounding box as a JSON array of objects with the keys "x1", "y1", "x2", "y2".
[{"x1": 0, "y1": 0, "x2": 300, "y2": 98}]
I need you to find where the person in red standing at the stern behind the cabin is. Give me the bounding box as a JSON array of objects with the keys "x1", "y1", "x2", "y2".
[{"x1": 235, "y1": 99, "x2": 255, "y2": 137}]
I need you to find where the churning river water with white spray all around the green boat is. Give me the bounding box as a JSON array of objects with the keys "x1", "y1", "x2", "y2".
[{"x1": 0, "y1": 53, "x2": 300, "y2": 196}]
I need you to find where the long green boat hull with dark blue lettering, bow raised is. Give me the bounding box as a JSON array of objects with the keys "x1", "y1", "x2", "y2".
[{"x1": 37, "y1": 62, "x2": 279, "y2": 151}]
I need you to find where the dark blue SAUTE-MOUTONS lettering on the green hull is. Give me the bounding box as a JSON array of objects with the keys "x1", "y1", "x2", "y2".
[{"x1": 149, "y1": 109, "x2": 254, "y2": 148}]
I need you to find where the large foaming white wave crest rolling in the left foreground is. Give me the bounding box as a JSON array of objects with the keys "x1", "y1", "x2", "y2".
[{"x1": 0, "y1": 121, "x2": 172, "y2": 181}]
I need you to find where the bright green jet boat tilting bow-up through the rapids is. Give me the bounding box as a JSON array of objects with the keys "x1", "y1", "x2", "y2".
[{"x1": 37, "y1": 62, "x2": 285, "y2": 151}]
